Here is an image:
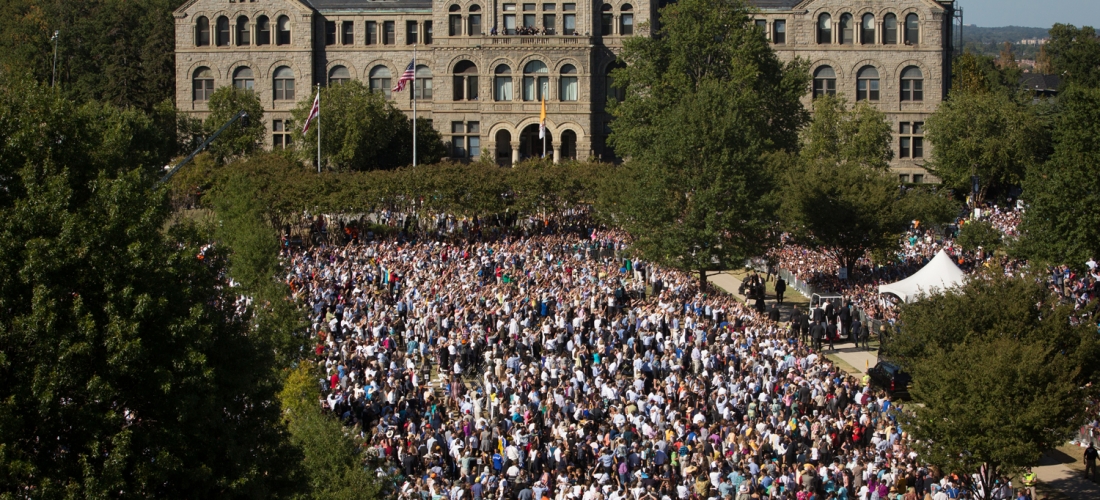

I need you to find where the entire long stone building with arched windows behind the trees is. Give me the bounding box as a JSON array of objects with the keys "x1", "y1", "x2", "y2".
[{"x1": 175, "y1": 0, "x2": 953, "y2": 175}]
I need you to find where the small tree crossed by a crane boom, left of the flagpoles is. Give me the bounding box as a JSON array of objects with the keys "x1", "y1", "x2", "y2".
[{"x1": 202, "y1": 86, "x2": 266, "y2": 163}]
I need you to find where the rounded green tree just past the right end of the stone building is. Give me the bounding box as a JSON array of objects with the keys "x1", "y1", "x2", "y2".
[{"x1": 925, "y1": 91, "x2": 1048, "y2": 203}]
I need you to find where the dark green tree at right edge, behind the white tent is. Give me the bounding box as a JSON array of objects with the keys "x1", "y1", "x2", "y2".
[{"x1": 1021, "y1": 86, "x2": 1100, "y2": 269}]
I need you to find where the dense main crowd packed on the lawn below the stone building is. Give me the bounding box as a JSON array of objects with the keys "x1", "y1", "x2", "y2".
[{"x1": 277, "y1": 212, "x2": 1029, "y2": 500}]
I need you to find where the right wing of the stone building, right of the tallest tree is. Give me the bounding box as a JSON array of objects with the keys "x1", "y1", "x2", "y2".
[{"x1": 757, "y1": 0, "x2": 955, "y2": 182}]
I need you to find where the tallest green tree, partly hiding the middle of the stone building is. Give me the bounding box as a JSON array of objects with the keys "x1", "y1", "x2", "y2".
[{"x1": 609, "y1": 0, "x2": 809, "y2": 285}]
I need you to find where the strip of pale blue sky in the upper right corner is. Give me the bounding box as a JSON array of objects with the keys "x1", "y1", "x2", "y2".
[{"x1": 956, "y1": 0, "x2": 1100, "y2": 29}]
